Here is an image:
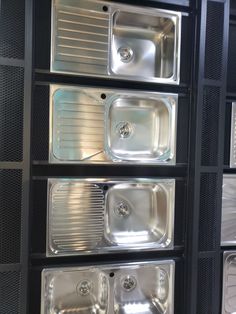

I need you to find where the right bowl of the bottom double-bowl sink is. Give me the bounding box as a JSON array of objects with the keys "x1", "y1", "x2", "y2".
[{"x1": 114, "y1": 265, "x2": 171, "y2": 314}]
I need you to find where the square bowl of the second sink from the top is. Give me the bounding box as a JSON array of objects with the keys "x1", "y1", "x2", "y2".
[{"x1": 105, "y1": 96, "x2": 175, "y2": 161}]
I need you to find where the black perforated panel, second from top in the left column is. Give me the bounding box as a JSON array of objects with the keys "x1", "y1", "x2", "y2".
[{"x1": 0, "y1": 65, "x2": 24, "y2": 161}]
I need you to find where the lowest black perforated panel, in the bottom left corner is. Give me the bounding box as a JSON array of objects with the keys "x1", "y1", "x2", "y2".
[{"x1": 0, "y1": 271, "x2": 21, "y2": 314}]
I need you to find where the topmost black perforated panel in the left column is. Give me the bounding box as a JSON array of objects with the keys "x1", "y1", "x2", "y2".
[{"x1": 0, "y1": 0, "x2": 25, "y2": 59}]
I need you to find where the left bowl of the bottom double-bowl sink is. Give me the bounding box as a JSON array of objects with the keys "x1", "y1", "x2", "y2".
[{"x1": 41, "y1": 268, "x2": 109, "y2": 314}]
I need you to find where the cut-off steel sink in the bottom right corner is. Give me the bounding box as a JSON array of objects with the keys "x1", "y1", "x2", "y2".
[{"x1": 222, "y1": 251, "x2": 236, "y2": 314}]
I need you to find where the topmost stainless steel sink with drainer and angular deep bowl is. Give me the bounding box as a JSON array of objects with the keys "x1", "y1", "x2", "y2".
[{"x1": 51, "y1": 0, "x2": 181, "y2": 84}]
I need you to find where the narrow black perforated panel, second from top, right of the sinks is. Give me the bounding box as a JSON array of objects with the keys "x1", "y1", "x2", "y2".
[{"x1": 202, "y1": 86, "x2": 220, "y2": 166}]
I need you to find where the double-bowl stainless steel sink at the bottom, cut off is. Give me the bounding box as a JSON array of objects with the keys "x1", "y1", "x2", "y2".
[{"x1": 41, "y1": 260, "x2": 175, "y2": 314}]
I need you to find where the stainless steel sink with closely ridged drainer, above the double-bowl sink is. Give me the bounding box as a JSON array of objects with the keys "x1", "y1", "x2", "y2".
[{"x1": 47, "y1": 179, "x2": 175, "y2": 256}]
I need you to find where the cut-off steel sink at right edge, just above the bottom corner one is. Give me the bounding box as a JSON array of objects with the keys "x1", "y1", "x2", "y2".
[{"x1": 221, "y1": 174, "x2": 236, "y2": 246}]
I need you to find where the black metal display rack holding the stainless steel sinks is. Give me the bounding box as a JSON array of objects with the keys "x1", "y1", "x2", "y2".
[{"x1": 0, "y1": 0, "x2": 232, "y2": 314}]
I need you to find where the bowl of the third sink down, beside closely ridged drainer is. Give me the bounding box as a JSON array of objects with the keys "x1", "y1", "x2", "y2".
[{"x1": 105, "y1": 183, "x2": 168, "y2": 246}]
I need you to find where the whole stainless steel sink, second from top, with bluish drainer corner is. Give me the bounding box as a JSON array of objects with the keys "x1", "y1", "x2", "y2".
[{"x1": 49, "y1": 85, "x2": 178, "y2": 164}]
